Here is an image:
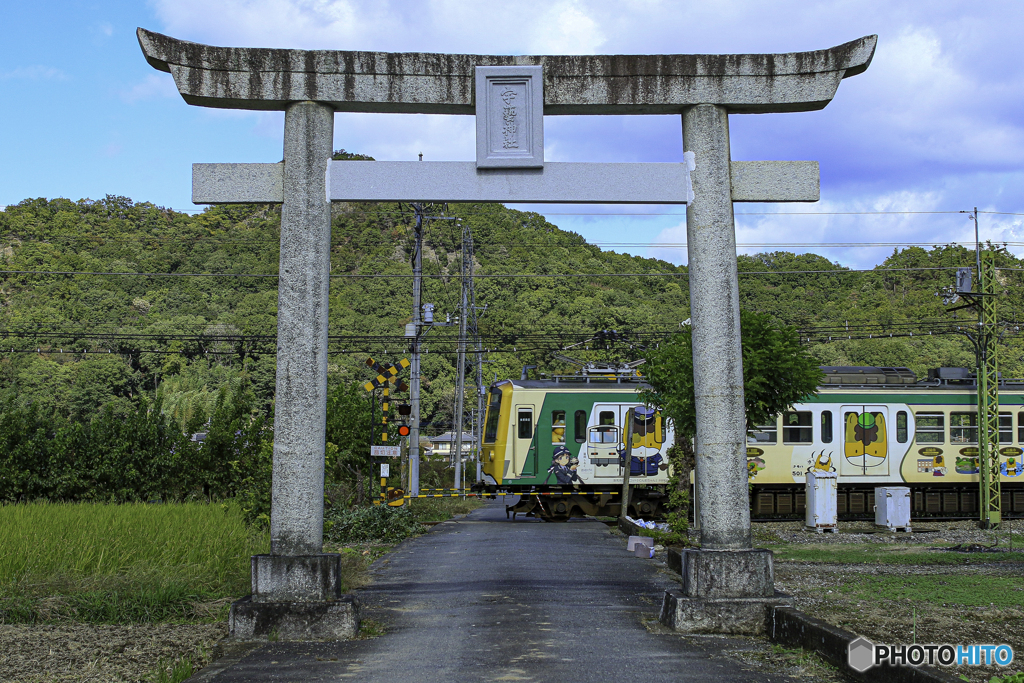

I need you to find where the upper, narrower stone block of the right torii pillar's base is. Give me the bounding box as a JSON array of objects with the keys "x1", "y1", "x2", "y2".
[{"x1": 680, "y1": 548, "x2": 775, "y2": 599}]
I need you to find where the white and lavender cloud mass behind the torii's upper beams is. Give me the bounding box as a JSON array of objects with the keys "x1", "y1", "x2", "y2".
[{"x1": 140, "y1": 0, "x2": 1024, "y2": 266}]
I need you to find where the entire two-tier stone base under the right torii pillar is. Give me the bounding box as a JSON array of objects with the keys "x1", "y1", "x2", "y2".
[{"x1": 660, "y1": 548, "x2": 791, "y2": 634}]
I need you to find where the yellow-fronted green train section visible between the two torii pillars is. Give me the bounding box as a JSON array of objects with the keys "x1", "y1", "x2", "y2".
[{"x1": 480, "y1": 369, "x2": 672, "y2": 520}]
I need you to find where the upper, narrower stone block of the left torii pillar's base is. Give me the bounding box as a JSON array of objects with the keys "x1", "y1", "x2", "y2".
[{"x1": 252, "y1": 553, "x2": 341, "y2": 602}]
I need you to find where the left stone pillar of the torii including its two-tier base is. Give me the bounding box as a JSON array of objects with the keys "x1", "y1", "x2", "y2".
[{"x1": 230, "y1": 101, "x2": 359, "y2": 640}]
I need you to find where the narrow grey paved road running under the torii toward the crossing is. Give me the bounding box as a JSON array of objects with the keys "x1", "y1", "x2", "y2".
[{"x1": 198, "y1": 501, "x2": 781, "y2": 683}]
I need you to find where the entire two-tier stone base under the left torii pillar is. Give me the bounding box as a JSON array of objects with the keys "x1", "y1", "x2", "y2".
[{"x1": 228, "y1": 553, "x2": 359, "y2": 640}]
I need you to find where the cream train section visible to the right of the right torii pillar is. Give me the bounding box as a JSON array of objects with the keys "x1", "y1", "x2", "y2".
[{"x1": 746, "y1": 368, "x2": 1024, "y2": 518}]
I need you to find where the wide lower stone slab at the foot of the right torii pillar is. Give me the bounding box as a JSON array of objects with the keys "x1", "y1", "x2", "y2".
[{"x1": 659, "y1": 591, "x2": 792, "y2": 635}]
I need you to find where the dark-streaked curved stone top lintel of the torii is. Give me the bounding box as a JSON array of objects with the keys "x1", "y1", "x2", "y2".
[{"x1": 137, "y1": 28, "x2": 878, "y2": 115}]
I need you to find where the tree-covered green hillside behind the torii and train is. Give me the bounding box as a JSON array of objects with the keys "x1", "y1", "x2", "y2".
[{"x1": 0, "y1": 192, "x2": 1024, "y2": 430}]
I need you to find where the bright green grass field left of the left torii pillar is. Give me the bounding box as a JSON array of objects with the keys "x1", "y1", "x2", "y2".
[{"x1": 0, "y1": 503, "x2": 269, "y2": 624}]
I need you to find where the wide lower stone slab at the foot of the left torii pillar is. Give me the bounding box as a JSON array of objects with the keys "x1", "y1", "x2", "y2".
[{"x1": 228, "y1": 595, "x2": 360, "y2": 641}]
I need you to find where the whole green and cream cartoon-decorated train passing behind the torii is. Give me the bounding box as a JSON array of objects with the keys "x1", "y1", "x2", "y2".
[{"x1": 481, "y1": 368, "x2": 1024, "y2": 520}]
